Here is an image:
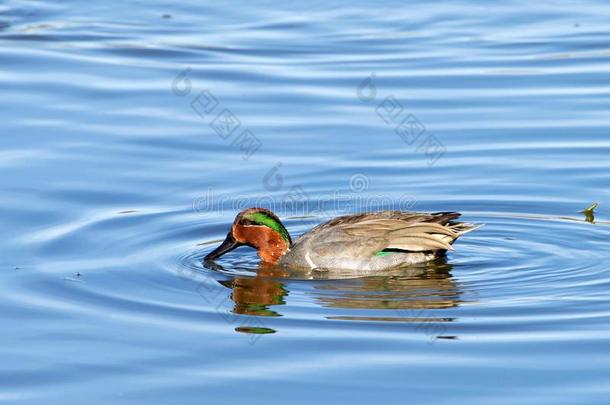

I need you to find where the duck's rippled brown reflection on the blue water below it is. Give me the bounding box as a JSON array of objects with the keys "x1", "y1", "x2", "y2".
[{"x1": 207, "y1": 260, "x2": 462, "y2": 332}]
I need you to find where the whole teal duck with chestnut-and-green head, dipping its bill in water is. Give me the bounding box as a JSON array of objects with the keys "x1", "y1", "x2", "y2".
[{"x1": 204, "y1": 207, "x2": 479, "y2": 272}]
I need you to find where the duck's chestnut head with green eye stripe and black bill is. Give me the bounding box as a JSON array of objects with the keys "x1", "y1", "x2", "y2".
[{"x1": 205, "y1": 208, "x2": 292, "y2": 264}]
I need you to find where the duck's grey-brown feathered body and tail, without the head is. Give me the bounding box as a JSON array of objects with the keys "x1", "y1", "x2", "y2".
[{"x1": 279, "y1": 211, "x2": 473, "y2": 270}]
